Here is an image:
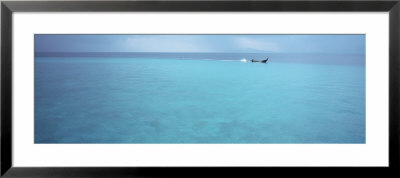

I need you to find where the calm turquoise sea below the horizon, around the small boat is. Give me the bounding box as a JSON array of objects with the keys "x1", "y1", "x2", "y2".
[{"x1": 34, "y1": 54, "x2": 366, "y2": 143}]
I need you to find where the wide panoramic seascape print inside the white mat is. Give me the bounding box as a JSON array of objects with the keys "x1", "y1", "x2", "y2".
[{"x1": 34, "y1": 34, "x2": 366, "y2": 144}]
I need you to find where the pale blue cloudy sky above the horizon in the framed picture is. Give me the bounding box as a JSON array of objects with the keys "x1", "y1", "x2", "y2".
[{"x1": 35, "y1": 35, "x2": 365, "y2": 54}]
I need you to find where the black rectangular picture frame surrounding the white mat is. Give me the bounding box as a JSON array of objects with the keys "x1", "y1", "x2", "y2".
[{"x1": 1, "y1": 0, "x2": 400, "y2": 177}]
